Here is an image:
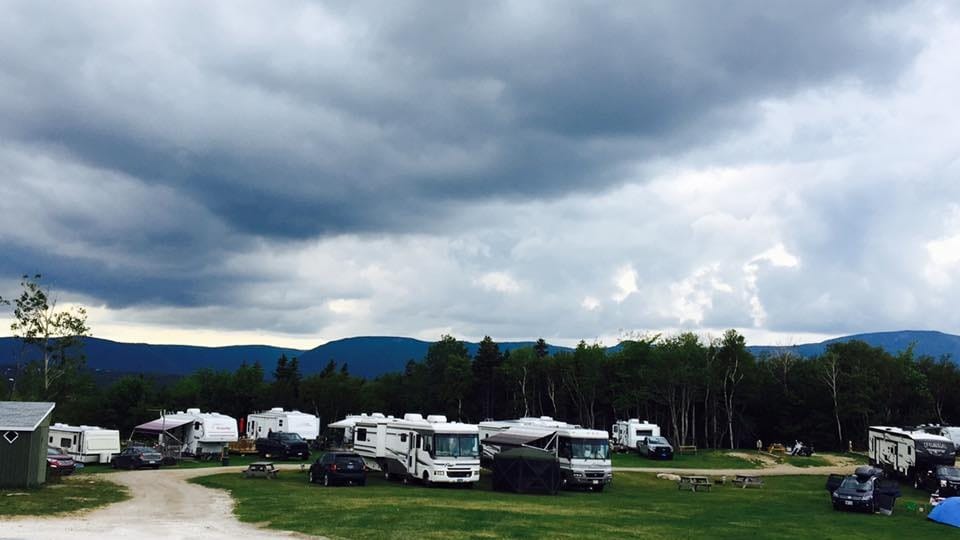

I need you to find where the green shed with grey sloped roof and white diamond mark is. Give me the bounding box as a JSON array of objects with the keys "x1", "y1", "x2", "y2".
[{"x1": 0, "y1": 401, "x2": 56, "y2": 489}]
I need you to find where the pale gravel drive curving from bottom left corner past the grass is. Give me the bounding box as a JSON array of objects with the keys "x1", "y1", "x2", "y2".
[{"x1": 0, "y1": 467, "x2": 320, "y2": 540}]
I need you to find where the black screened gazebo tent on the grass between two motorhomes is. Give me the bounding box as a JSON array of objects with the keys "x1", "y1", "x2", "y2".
[{"x1": 493, "y1": 448, "x2": 561, "y2": 495}]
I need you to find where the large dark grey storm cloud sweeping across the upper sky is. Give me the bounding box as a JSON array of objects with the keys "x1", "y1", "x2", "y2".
[{"x1": 0, "y1": 2, "x2": 913, "y2": 238}]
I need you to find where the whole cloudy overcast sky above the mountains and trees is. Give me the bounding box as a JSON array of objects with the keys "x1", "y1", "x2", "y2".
[{"x1": 0, "y1": 0, "x2": 960, "y2": 348}]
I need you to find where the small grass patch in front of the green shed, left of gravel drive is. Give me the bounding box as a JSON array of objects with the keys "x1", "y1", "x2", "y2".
[{"x1": 0, "y1": 476, "x2": 130, "y2": 516}]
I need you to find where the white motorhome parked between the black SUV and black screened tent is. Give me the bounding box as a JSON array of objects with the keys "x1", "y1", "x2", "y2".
[{"x1": 353, "y1": 414, "x2": 480, "y2": 484}]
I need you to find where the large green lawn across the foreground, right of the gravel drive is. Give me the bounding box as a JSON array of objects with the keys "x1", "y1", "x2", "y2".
[{"x1": 193, "y1": 472, "x2": 954, "y2": 540}]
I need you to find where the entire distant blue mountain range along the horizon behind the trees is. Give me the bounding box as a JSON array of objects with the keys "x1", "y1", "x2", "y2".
[{"x1": 0, "y1": 331, "x2": 960, "y2": 378}]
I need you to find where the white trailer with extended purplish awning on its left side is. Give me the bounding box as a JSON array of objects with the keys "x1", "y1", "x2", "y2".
[{"x1": 134, "y1": 409, "x2": 239, "y2": 457}]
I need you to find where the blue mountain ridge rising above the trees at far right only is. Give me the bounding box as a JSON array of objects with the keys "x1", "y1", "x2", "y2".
[{"x1": 748, "y1": 330, "x2": 960, "y2": 362}]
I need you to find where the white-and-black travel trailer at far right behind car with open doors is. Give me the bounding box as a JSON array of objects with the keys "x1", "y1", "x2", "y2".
[{"x1": 867, "y1": 426, "x2": 956, "y2": 479}]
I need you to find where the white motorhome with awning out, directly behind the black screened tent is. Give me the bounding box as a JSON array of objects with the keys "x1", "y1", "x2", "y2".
[{"x1": 479, "y1": 416, "x2": 613, "y2": 491}]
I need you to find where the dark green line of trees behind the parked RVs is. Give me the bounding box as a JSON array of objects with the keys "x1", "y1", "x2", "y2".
[{"x1": 3, "y1": 280, "x2": 960, "y2": 449}]
